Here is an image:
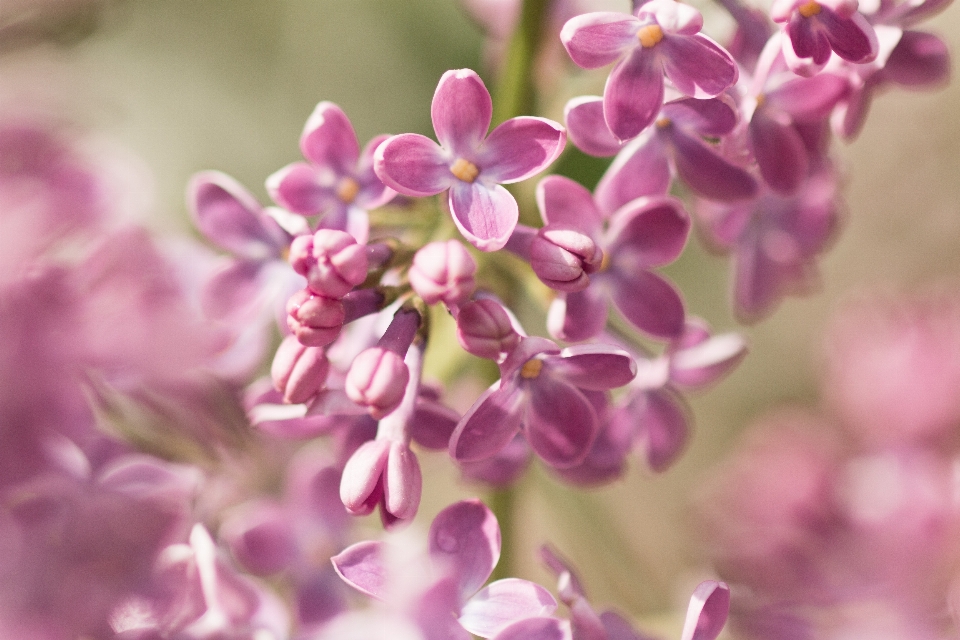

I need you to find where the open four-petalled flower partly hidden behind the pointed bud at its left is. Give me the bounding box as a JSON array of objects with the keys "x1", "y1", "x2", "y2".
[{"x1": 517, "y1": 175, "x2": 690, "y2": 341}]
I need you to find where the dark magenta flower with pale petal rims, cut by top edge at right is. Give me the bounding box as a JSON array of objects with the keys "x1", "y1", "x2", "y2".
[{"x1": 770, "y1": 0, "x2": 877, "y2": 76}]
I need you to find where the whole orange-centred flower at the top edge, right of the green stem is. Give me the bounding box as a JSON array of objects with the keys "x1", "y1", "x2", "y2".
[{"x1": 560, "y1": 0, "x2": 738, "y2": 140}]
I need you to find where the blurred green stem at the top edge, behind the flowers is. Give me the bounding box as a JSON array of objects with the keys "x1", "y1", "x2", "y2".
[{"x1": 493, "y1": 0, "x2": 550, "y2": 125}]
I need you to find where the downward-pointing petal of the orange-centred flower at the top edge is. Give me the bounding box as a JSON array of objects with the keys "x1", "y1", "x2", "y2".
[{"x1": 603, "y1": 45, "x2": 663, "y2": 141}]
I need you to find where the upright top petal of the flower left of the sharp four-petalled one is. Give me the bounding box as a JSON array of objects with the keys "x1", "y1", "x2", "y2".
[{"x1": 300, "y1": 102, "x2": 360, "y2": 176}]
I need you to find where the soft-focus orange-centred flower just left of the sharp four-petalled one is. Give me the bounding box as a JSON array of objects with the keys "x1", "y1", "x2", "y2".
[{"x1": 267, "y1": 102, "x2": 396, "y2": 244}]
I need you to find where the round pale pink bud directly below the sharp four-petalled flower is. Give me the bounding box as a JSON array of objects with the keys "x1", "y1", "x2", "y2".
[{"x1": 408, "y1": 240, "x2": 477, "y2": 306}]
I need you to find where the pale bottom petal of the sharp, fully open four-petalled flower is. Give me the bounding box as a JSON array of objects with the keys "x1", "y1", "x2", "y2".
[{"x1": 450, "y1": 180, "x2": 520, "y2": 251}]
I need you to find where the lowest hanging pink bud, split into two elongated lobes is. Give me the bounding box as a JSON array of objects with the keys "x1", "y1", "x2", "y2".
[{"x1": 340, "y1": 439, "x2": 423, "y2": 525}]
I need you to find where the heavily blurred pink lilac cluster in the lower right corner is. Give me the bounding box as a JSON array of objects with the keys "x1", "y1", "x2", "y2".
[{"x1": 700, "y1": 292, "x2": 960, "y2": 640}]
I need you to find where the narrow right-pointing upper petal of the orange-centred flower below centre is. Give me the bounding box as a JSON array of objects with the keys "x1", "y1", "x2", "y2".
[{"x1": 548, "y1": 344, "x2": 637, "y2": 391}]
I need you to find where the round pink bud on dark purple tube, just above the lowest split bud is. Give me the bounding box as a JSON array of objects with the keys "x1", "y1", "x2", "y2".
[{"x1": 344, "y1": 347, "x2": 410, "y2": 420}]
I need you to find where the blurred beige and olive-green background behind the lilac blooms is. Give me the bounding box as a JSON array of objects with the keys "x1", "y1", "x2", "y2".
[{"x1": 0, "y1": 0, "x2": 960, "y2": 632}]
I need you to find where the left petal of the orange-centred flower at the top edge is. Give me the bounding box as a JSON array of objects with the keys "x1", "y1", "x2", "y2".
[{"x1": 560, "y1": 11, "x2": 640, "y2": 69}]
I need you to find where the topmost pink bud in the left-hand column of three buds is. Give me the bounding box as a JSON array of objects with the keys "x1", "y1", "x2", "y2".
[{"x1": 290, "y1": 229, "x2": 369, "y2": 298}]
